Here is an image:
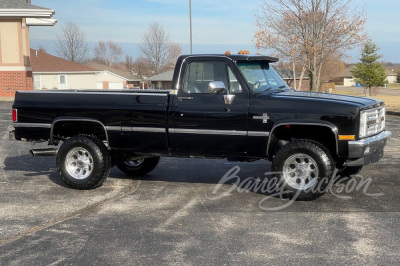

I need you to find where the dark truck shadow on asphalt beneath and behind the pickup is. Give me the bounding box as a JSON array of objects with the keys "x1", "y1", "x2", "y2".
[{"x1": 4, "y1": 154, "x2": 276, "y2": 194}]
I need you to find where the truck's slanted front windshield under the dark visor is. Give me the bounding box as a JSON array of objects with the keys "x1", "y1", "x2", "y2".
[{"x1": 237, "y1": 61, "x2": 289, "y2": 93}]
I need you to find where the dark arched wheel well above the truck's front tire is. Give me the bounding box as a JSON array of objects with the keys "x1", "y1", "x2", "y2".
[{"x1": 267, "y1": 125, "x2": 337, "y2": 159}]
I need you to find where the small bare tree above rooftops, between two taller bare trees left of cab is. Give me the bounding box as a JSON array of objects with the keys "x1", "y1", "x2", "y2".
[{"x1": 94, "y1": 41, "x2": 123, "y2": 66}]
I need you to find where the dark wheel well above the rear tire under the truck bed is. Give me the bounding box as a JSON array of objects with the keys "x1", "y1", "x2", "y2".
[{"x1": 51, "y1": 121, "x2": 107, "y2": 141}]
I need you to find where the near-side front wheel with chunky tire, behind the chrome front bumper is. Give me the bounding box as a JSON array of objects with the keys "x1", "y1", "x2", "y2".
[{"x1": 272, "y1": 140, "x2": 335, "y2": 200}]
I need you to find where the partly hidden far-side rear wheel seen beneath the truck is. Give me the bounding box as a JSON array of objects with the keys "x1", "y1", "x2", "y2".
[{"x1": 117, "y1": 157, "x2": 160, "y2": 176}]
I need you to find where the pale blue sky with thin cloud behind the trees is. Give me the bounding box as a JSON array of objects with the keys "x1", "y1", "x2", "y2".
[{"x1": 30, "y1": 0, "x2": 400, "y2": 62}]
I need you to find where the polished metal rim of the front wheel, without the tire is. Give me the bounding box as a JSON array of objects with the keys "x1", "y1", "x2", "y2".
[{"x1": 282, "y1": 153, "x2": 319, "y2": 190}]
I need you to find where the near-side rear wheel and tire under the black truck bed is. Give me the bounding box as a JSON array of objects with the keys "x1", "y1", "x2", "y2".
[{"x1": 57, "y1": 135, "x2": 111, "y2": 189}]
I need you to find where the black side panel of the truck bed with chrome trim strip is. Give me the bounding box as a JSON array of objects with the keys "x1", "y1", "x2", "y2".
[{"x1": 13, "y1": 91, "x2": 168, "y2": 152}]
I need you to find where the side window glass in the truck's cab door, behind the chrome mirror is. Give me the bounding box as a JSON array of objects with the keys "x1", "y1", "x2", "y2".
[{"x1": 182, "y1": 61, "x2": 242, "y2": 93}]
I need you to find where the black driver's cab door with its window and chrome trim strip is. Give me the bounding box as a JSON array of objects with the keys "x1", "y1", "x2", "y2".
[{"x1": 169, "y1": 59, "x2": 249, "y2": 156}]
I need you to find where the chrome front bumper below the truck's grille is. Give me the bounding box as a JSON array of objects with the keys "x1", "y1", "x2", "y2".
[{"x1": 347, "y1": 131, "x2": 392, "y2": 166}]
